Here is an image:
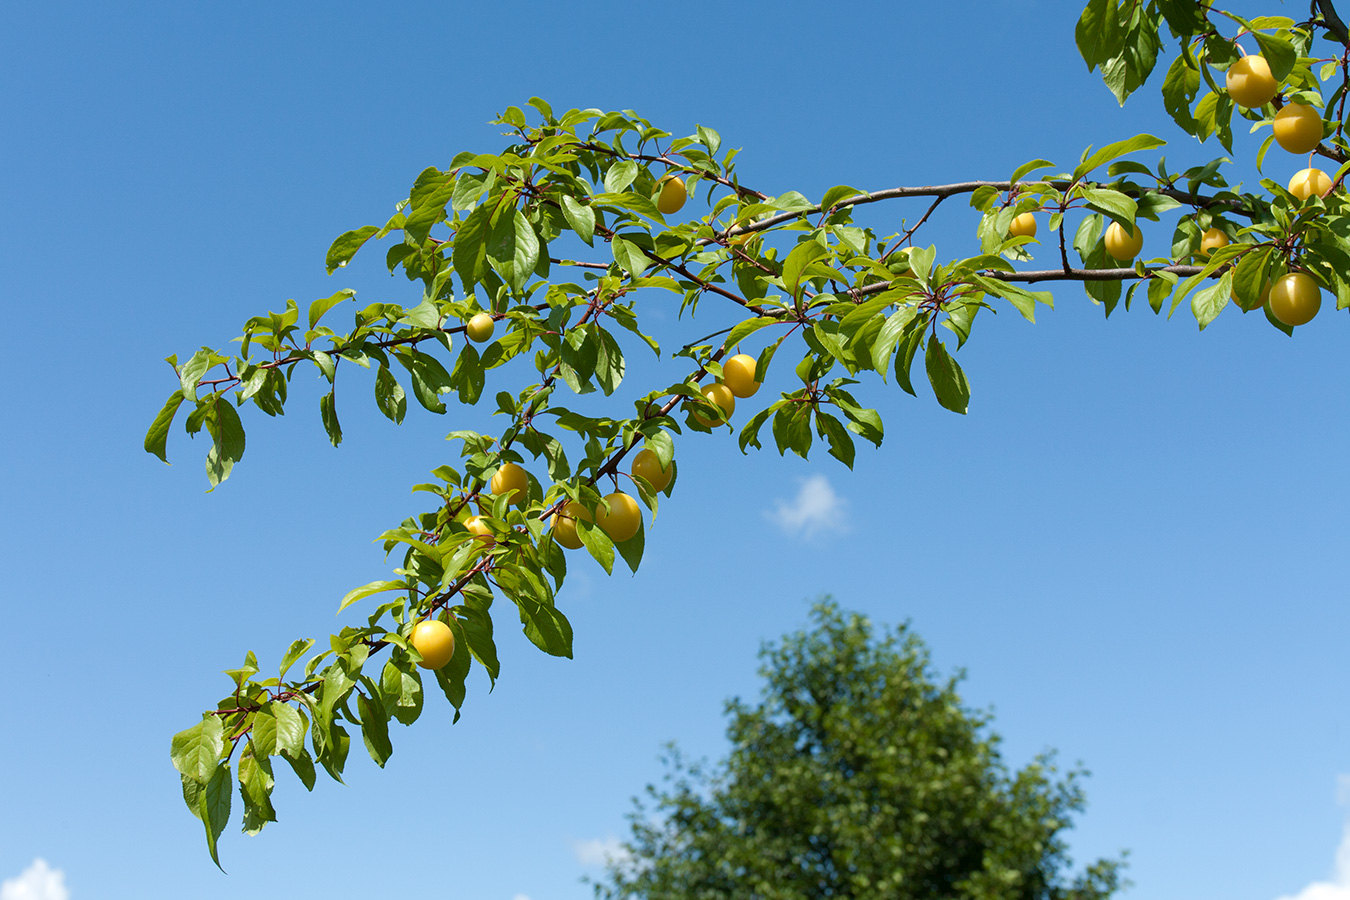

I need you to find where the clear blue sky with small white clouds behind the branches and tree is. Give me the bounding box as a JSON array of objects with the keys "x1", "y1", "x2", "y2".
[{"x1": 0, "y1": 1, "x2": 1350, "y2": 900}]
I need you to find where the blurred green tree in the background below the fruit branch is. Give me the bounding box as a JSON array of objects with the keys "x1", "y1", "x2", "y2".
[{"x1": 595, "y1": 600, "x2": 1122, "y2": 900}]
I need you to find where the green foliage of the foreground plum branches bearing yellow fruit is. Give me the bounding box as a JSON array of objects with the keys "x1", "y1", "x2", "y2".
[{"x1": 153, "y1": 0, "x2": 1350, "y2": 858}]
